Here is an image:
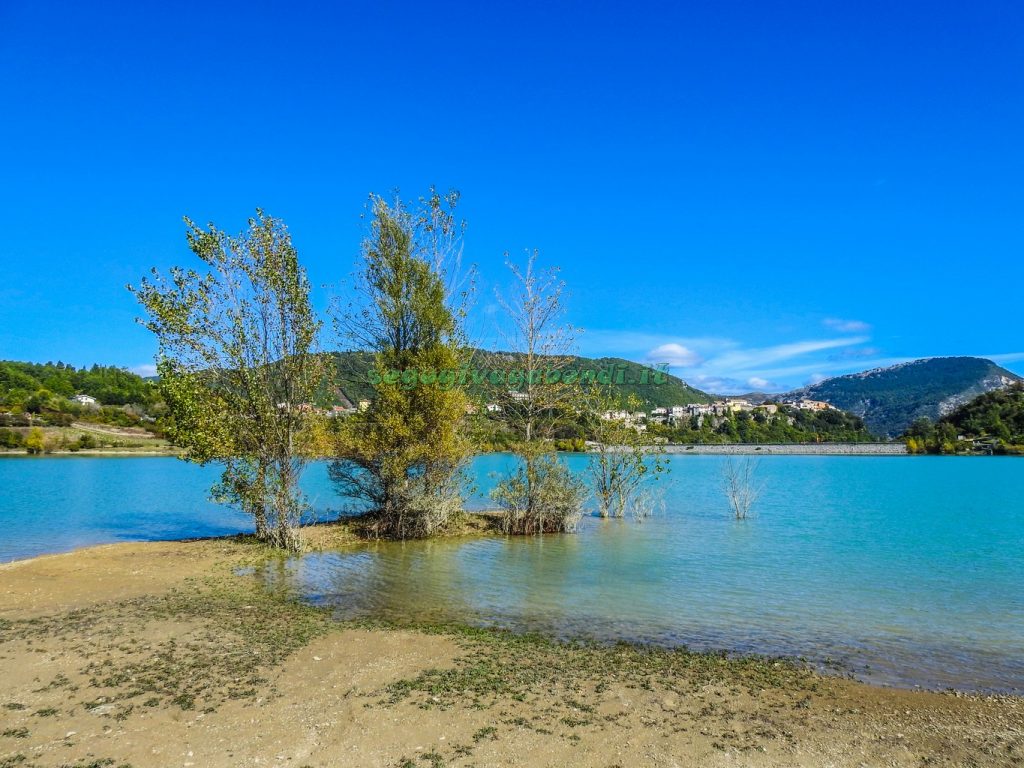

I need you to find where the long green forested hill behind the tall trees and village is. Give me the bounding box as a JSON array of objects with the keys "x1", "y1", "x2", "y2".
[{"x1": 317, "y1": 350, "x2": 715, "y2": 408}]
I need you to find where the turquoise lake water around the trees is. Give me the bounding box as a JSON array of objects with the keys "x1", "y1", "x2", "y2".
[{"x1": 0, "y1": 456, "x2": 1024, "y2": 693}]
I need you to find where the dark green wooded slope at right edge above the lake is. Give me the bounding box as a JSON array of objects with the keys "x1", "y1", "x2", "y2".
[{"x1": 903, "y1": 382, "x2": 1024, "y2": 454}]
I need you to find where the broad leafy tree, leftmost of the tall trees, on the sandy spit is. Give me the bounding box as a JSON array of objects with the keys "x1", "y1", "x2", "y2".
[{"x1": 129, "y1": 210, "x2": 322, "y2": 550}]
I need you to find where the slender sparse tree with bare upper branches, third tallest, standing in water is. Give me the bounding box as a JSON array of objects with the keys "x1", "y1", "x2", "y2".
[{"x1": 492, "y1": 251, "x2": 586, "y2": 534}]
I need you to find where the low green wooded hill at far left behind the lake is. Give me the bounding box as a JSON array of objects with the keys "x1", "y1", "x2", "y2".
[{"x1": 0, "y1": 360, "x2": 158, "y2": 407}]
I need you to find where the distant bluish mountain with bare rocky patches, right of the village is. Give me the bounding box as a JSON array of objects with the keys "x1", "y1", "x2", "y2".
[{"x1": 785, "y1": 357, "x2": 1021, "y2": 437}]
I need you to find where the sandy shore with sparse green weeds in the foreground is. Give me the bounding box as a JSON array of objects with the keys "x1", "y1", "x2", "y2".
[{"x1": 0, "y1": 531, "x2": 1024, "y2": 768}]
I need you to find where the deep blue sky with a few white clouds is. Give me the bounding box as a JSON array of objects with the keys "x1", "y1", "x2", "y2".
[{"x1": 0, "y1": 1, "x2": 1024, "y2": 392}]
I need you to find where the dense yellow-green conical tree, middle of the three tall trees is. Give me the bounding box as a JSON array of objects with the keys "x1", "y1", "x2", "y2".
[{"x1": 330, "y1": 191, "x2": 470, "y2": 539}]
